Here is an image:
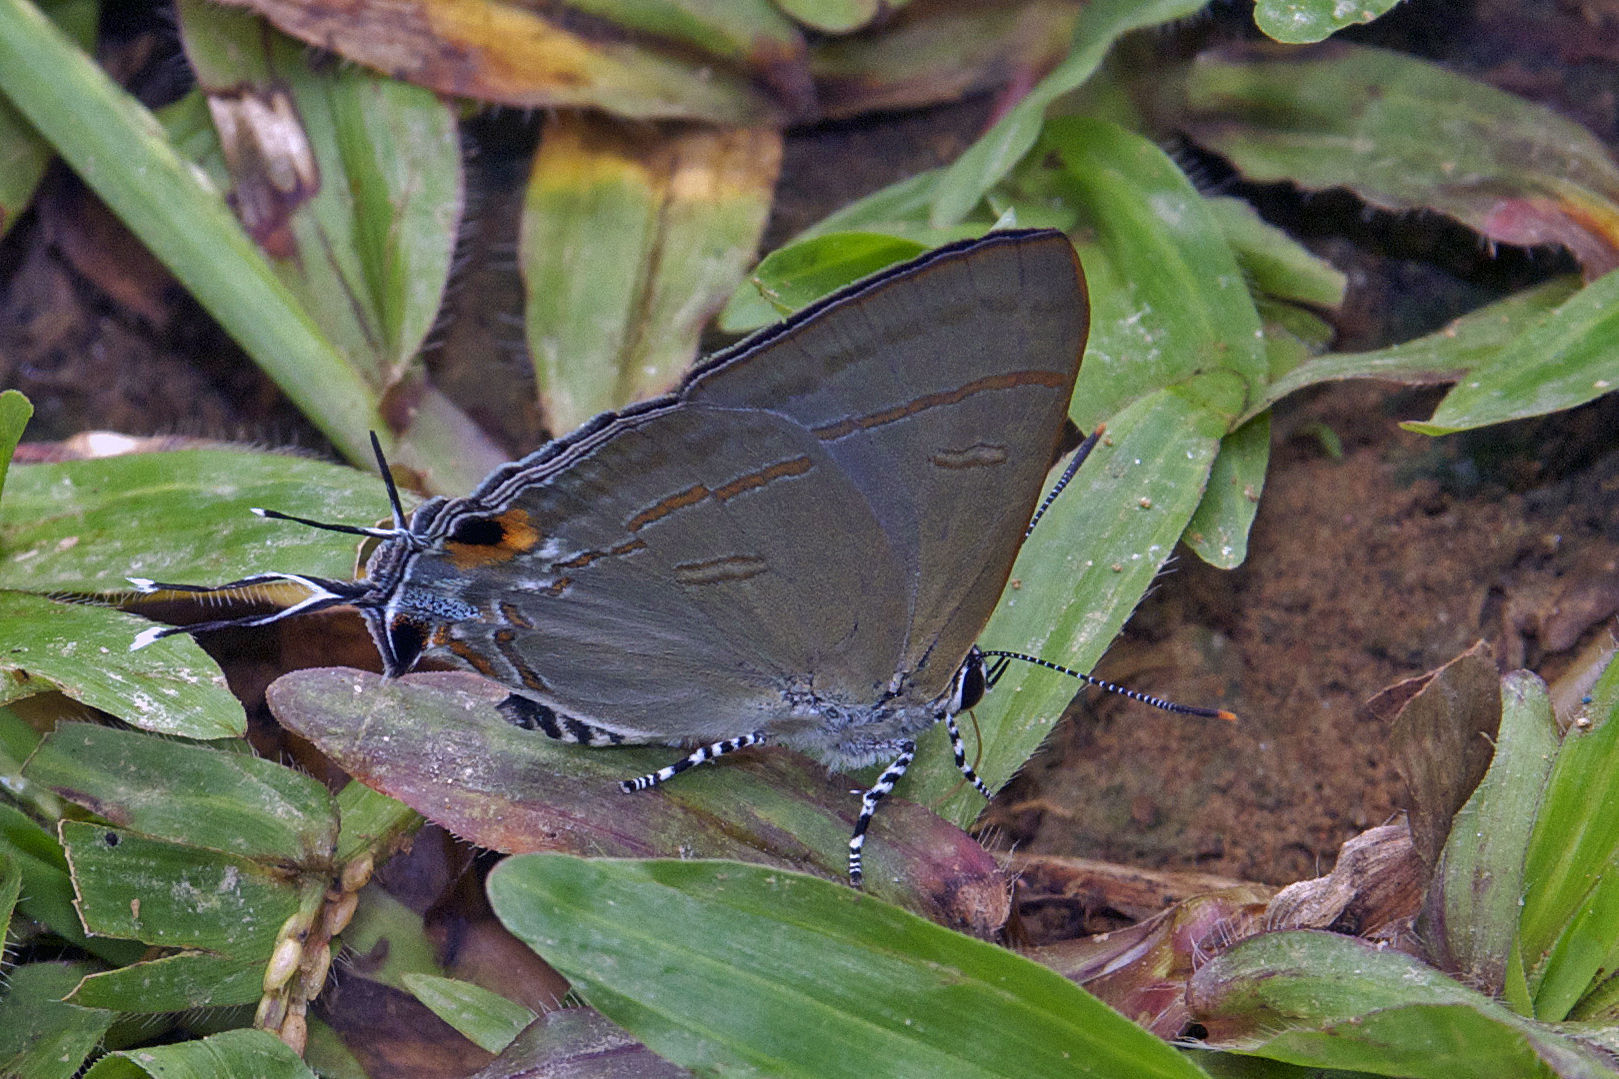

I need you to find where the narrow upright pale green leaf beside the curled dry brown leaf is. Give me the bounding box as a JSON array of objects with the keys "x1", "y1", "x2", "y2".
[{"x1": 1418, "y1": 671, "x2": 1557, "y2": 993}]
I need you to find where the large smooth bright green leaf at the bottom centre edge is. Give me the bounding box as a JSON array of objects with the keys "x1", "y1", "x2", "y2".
[{"x1": 487, "y1": 854, "x2": 1201, "y2": 1079}]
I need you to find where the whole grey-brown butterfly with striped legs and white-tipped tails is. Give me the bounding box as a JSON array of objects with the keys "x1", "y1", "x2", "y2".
[{"x1": 131, "y1": 230, "x2": 1139, "y2": 886}]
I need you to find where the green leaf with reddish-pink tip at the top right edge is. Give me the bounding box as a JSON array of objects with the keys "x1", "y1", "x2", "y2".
[{"x1": 1177, "y1": 44, "x2": 1619, "y2": 275}]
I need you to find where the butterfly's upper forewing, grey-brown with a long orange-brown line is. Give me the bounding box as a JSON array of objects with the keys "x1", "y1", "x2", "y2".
[{"x1": 685, "y1": 232, "x2": 1090, "y2": 700}]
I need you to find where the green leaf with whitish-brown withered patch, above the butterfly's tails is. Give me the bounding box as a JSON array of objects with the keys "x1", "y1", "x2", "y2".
[{"x1": 176, "y1": 2, "x2": 505, "y2": 494}]
